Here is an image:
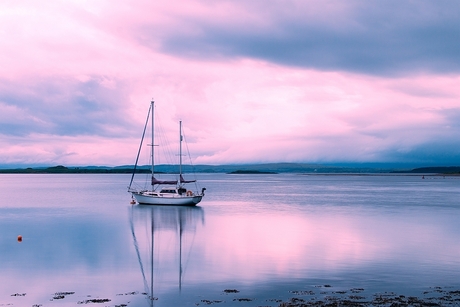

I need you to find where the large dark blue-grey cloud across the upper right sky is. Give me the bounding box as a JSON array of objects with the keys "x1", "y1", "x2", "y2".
[{"x1": 152, "y1": 1, "x2": 460, "y2": 76}]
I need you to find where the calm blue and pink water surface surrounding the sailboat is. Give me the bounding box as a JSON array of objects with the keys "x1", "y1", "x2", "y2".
[{"x1": 0, "y1": 174, "x2": 460, "y2": 306}]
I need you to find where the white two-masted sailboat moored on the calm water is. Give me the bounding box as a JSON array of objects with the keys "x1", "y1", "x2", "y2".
[{"x1": 128, "y1": 100, "x2": 206, "y2": 206}]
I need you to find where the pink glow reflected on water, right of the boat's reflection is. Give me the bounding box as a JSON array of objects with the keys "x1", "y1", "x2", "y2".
[{"x1": 197, "y1": 214, "x2": 459, "y2": 280}]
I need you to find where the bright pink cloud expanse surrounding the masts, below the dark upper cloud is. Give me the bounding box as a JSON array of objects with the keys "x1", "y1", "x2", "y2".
[{"x1": 0, "y1": 1, "x2": 460, "y2": 165}]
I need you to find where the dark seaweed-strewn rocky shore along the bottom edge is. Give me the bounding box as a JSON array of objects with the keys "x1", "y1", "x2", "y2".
[{"x1": 0, "y1": 285, "x2": 460, "y2": 307}]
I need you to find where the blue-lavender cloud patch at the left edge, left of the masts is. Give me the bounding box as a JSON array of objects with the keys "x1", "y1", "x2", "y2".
[{"x1": 0, "y1": 77, "x2": 135, "y2": 137}]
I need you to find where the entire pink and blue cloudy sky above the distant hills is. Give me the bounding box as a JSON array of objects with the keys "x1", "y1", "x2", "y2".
[{"x1": 0, "y1": 0, "x2": 460, "y2": 165}]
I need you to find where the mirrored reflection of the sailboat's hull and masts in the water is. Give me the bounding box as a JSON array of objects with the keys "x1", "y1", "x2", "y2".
[{"x1": 130, "y1": 205, "x2": 204, "y2": 306}]
